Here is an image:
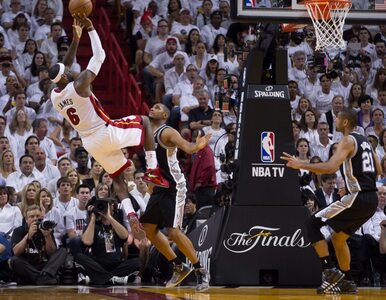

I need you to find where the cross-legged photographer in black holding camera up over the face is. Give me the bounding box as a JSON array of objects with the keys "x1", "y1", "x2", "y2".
[{"x1": 74, "y1": 198, "x2": 138, "y2": 285}]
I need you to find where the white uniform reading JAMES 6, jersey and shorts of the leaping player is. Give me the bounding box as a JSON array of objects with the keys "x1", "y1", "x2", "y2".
[{"x1": 51, "y1": 82, "x2": 144, "y2": 176}]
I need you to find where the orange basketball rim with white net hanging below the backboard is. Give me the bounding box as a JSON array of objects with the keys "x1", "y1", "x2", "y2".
[{"x1": 305, "y1": 0, "x2": 352, "y2": 51}]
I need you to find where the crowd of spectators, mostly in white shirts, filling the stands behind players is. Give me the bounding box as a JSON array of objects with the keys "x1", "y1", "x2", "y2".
[{"x1": 0, "y1": 0, "x2": 386, "y2": 284}]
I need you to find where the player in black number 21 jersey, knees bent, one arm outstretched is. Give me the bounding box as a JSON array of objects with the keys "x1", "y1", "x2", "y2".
[{"x1": 281, "y1": 108, "x2": 381, "y2": 294}]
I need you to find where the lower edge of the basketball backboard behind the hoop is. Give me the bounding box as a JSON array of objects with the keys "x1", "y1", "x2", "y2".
[{"x1": 231, "y1": 0, "x2": 386, "y2": 25}]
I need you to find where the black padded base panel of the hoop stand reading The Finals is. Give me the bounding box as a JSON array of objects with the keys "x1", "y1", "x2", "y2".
[{"x1": 212, "y1": 206, "x2": 321, "y2": 286}]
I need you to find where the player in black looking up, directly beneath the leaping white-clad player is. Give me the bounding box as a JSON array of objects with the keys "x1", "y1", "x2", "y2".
[{"x1": 141, "y1": 103, "x2": 211, "y2": 292}]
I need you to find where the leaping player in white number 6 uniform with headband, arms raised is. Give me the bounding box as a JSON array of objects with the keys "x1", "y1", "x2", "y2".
[{"x1": 49, "y1": 15, "x2": 169, "y2": 187}]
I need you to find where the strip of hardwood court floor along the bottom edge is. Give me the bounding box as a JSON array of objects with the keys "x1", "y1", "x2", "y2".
[{"x1": 0, "y1": 286, "x2": 386, "y2": 300}]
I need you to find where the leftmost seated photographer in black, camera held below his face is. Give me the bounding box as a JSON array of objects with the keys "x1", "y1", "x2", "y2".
[{"x1": 10, "y1": 205, "x2": 66, "y2": 285}]
